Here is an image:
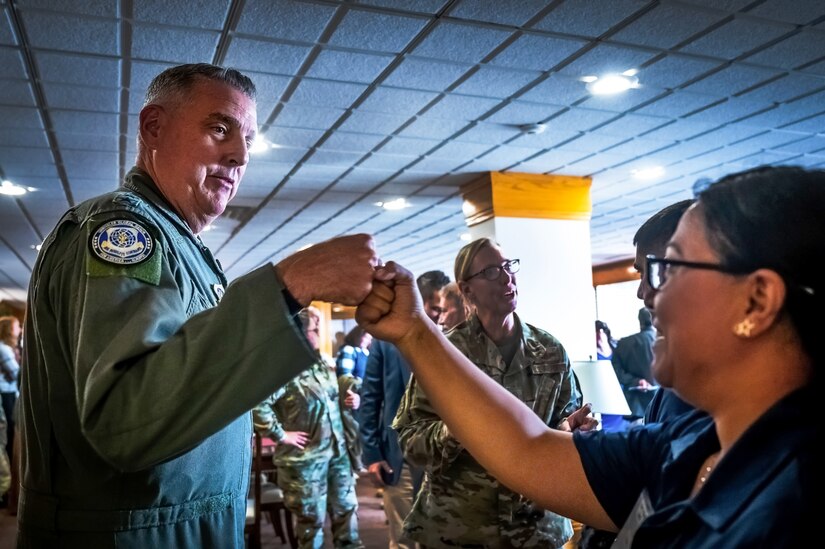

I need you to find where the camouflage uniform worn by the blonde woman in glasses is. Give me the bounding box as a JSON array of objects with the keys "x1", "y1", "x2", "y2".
[{"x1": 393, "y1": 315, "x2": 581, "y2": 548}]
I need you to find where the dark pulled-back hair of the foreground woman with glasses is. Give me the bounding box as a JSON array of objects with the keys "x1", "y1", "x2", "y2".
[{"x1": 697, "y1": 167, "x2": 825, "y2": 364}]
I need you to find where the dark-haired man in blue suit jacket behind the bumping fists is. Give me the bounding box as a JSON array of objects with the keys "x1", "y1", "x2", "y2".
[{"x1": 360, "y1": 271, "x2": 450, "y2": 549}]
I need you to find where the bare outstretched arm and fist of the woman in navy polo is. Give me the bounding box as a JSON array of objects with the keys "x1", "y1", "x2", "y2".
[{"x1": 356, "y1": 263, "x2": 616, "y2": 529}]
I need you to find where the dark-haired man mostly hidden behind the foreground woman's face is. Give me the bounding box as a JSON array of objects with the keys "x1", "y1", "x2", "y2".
[{"x1": 633, "y1": 198, "x2": 694, "y2": 423}]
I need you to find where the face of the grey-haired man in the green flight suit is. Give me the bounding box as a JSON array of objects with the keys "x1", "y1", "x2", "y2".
[{"x1": 147, "y1": 79, "x2": 257, "y2": 233}]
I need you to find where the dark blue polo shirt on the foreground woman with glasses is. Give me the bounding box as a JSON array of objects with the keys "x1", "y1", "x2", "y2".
[{"x1": 574, "y1": 388, "x2": 822, "y2": 549}]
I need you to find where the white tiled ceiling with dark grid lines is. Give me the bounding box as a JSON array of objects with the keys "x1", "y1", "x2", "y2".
[{"x1": 0, "y1": 0, "x2": 825, "y2": 299}]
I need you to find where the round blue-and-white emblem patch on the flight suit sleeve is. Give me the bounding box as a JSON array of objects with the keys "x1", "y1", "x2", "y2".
[{"x1": 89, "y1": 219, "x2": 155, "y2": 265}]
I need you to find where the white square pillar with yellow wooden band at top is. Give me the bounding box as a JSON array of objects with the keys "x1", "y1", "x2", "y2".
[{"x1": 461, "y1": 172, "x2": 596, "y2": 360}]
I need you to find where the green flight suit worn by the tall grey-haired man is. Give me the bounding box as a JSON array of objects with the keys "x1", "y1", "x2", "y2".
[{"x1": 18, "y1": 168, "x2": 314, "y2": 549}]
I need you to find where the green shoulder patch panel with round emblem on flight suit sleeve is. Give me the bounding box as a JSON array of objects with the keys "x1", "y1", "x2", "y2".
[{"x1": 86, "y1": 218, "x2": 162, "y2": 285}]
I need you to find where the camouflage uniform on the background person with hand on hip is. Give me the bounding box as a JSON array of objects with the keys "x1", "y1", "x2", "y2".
[{"x1": 253, "y1": 358, "x2": 363, "y2": 549}]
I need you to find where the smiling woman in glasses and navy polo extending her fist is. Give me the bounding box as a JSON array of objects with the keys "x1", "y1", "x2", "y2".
[{"x1": 356, "y1": 166, "x2": 825, "y2": 549}]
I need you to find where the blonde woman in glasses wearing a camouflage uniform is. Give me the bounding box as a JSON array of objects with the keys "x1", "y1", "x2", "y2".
[{"x1": 393, "y1": 238, "x2": 581, "y2": 548}]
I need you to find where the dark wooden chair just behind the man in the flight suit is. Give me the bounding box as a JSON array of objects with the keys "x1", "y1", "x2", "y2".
[{"x1": 244, "y1": 432, "x2": 298, "y2": 549}]
